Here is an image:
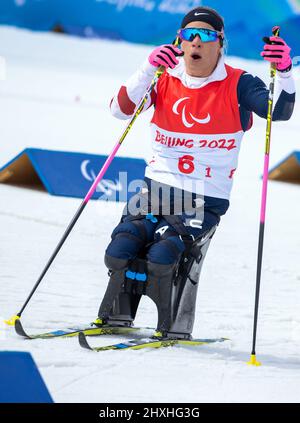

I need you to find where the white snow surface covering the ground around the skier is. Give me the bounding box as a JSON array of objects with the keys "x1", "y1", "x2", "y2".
[{"x1": 0, "y1": 27, "x2": 300, "y2": 403}]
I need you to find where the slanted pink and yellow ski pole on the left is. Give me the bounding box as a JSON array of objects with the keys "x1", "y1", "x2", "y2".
[{"x1": 5, "y1": 66, "x2": 165, "y2": 326}]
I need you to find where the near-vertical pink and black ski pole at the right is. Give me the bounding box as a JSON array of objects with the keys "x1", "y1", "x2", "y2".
[{"x1": 247, "y1": 26, "x2": 280, "y2": 366}]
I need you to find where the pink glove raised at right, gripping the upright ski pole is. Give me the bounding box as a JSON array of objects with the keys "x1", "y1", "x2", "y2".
[{"x1": 260, "y1": 36, "x2": 292, "y2": 72}]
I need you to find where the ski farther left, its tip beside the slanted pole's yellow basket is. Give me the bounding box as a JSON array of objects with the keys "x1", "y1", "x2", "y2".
[{"x1": 15, "y1": 319, "x2": 155, "y2": 339}]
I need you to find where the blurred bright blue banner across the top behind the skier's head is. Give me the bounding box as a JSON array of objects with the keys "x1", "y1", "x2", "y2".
[{"x1": 0, "y1": 0, "x2": 300, "y2": 59}]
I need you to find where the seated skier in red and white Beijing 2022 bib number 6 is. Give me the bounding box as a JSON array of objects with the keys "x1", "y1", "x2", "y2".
[{"x1": 98, "y1": 7, "x2": 295, "y2": 336}]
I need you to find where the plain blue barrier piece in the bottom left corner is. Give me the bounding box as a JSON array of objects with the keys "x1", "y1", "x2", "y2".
[{"x1": 0, "y1": 351, "x2": 53, "y2": 403}]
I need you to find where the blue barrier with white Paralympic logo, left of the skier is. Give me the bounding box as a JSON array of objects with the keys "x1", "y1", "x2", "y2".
[{"x1": 0, "y1": 148, "x2": 146, "y2": 202}]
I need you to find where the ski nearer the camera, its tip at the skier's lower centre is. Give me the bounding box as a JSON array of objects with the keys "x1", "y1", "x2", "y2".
[{"x1": 78, "y1": 332, "x2": 228, "y2": 352}]
